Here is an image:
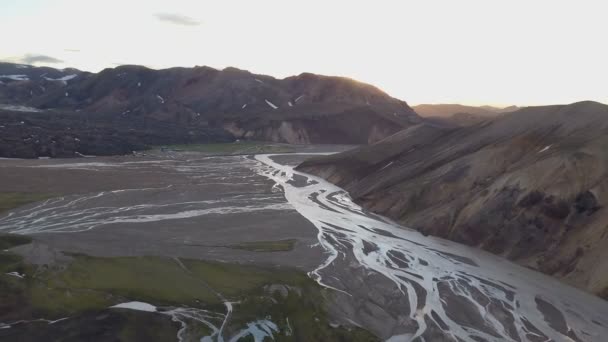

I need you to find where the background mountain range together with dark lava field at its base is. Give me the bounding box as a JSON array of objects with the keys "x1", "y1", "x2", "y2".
[{"x1": 0, "y1": 63, "x2": 421, "y2": 157}]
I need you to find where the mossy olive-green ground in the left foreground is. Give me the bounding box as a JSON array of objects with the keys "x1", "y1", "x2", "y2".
[{"x1": 0, "y1": 239, "x2": 377, "y2": 341}]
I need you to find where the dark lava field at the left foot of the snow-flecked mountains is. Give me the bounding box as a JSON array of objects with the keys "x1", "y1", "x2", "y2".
[{"x1": 0, "y1": 110, "x2": 234, "y2": 158}]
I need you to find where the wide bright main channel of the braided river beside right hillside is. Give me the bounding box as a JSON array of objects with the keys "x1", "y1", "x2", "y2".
[{"x1": 256, "y1": 155, "x2": 608, "y2": 341}]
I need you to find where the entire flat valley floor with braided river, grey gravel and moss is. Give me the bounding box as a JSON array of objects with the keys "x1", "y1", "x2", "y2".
[{"x1": 0, "y1": 147, "x2": 608, "y2": 341}]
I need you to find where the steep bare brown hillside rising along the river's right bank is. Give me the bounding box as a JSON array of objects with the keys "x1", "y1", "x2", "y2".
[{"x1": 299, "y1": 102, "x2": 608, "y2": 298}]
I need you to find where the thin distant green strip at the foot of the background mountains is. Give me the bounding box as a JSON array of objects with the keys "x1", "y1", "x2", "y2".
[{"x1": 154, "y1": 141, "x2": 295, "y2": 155}]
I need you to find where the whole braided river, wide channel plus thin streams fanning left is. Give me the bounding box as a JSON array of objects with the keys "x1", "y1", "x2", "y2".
[{"x1": 0, "y1": 154, "x2": 608, "y2": 341}]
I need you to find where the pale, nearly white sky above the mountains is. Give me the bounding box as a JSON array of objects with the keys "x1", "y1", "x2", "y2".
[{"x1": 0, "y1": 0, "x2": 608, "y2": 106}]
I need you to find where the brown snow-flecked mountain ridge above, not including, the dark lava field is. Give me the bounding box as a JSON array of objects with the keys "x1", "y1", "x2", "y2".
[{"x1": 0, "y1": 63, "x2": 420, "y2": 158}]
